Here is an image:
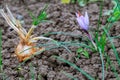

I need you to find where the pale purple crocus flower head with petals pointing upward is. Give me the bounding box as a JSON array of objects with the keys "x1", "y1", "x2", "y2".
[{"x1": 76, "y1": 12, "x2": 89, "y2": 31}]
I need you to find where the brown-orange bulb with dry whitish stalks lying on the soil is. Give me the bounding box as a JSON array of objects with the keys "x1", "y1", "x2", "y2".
[{"x1": 0, "y1": 6, "x2": 52, "y2": 62}]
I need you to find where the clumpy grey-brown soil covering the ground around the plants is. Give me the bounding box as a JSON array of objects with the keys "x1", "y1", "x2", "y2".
[{"x1": 0, "y1": 0, "x2": 120, "y2": 80}]
